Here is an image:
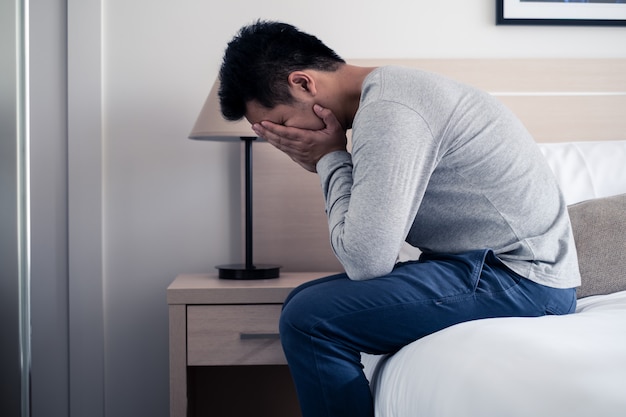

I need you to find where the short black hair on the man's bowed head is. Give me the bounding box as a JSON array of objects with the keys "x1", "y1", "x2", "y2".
[{"x1": 219, "y1": 20, "x2": 345, "y2": 120}]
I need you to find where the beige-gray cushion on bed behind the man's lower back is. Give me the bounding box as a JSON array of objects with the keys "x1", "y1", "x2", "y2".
[{"x1": 569, "y1": 194, "x2": 626, "y2": 298}]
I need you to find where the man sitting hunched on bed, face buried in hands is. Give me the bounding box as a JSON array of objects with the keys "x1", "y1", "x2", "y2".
[{"x1": 220, "y1": 21, "x2": 580, "y2": 417}]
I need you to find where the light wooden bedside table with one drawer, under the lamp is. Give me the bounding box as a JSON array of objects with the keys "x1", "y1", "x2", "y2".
[{"x1": 167, "y1": 272, "x2": 334, "y2": 417}]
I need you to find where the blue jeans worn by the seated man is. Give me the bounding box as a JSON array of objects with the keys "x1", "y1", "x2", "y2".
[{"x1": 280, "y1": 250, "x2": 576, "y2": 417}]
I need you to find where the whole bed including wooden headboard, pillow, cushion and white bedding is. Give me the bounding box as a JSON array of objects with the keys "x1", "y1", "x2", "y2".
[{"x1": 249, "y1": 59, "x2": 626, "y2": 417}]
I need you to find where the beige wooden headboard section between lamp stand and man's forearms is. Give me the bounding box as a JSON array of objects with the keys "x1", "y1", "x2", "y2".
[{"x1": 253, "y1": 143, "x2": 343, "y2": 271}]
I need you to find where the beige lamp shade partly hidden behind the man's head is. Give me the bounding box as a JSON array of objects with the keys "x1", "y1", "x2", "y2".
[{"x1": 189, "y1": 79, "x2": 256, "y2": 142}]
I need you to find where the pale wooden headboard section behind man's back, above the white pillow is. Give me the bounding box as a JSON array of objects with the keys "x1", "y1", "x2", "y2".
[{"x1": 350, "y1": 59, "x2": 626, "y2": 142}]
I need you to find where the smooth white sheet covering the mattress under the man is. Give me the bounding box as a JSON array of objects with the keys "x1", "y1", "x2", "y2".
[{"x1": 363, "y1": 291, "x2": 626, "y2": 417}]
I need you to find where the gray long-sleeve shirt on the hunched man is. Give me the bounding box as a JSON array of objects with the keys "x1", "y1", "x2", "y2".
[{"x1": 317, "y1": 67, "x2": 580, "y2": 288}]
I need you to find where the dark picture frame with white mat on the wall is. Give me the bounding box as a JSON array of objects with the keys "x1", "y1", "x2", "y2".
[{"x1": 496, "y1": 0, "x2": 626, "y2": 26}]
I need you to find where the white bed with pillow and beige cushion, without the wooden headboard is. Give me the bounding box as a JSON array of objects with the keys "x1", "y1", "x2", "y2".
[{"x1": 363, "y1": 141, "x2": 626, "y2": 417}]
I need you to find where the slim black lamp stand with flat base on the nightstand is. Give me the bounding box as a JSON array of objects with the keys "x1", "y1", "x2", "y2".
[{"x1": 215, "y1": 136, "x2": 280, "y2": 280}]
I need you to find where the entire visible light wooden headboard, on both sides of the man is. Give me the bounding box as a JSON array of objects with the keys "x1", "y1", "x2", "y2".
[{"x1": 253, "y1": 59, "x2": 626, "y2": 272}]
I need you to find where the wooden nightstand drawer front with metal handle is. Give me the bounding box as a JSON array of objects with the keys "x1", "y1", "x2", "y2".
[{"x1": 187, "y1": 304, "x2": 287, "y2": 366}]
